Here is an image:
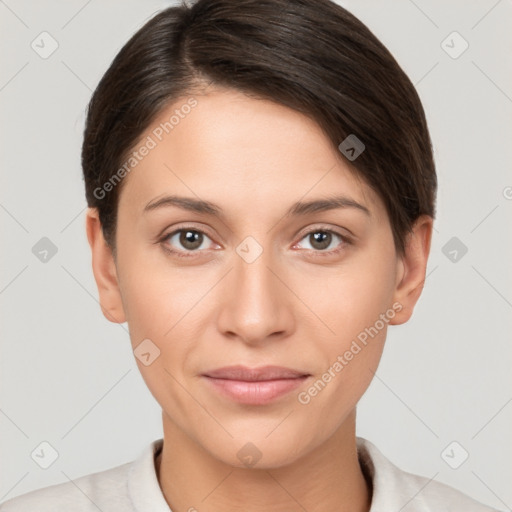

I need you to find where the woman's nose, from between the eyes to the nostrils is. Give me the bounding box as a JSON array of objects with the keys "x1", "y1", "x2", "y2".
[{"x1": 218, "y1": 241, "x2": 298, "y2": 345}]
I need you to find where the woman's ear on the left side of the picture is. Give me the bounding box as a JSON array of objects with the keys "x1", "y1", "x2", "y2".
[{"x1": 85, "y1": 208, "x2": 126, "y2": 324}]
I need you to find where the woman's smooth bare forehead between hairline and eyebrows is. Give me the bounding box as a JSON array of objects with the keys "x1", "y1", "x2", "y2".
[{"x1": 116, "y1": 90, "x2": 383, "y2": 218}]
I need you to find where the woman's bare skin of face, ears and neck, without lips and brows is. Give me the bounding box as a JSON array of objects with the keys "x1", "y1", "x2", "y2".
[{"x1": 86, "y1": 89, "x2": 432, "y2": 512}]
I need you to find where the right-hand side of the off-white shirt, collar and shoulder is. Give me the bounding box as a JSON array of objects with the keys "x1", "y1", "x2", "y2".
[{"x1": 357, "y1": 437, "x2": 504, "y2": 512}]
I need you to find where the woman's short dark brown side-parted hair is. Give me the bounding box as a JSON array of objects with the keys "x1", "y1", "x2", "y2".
[{"x1": 82, "y1": 0, "x2": 437, "y2": 254}]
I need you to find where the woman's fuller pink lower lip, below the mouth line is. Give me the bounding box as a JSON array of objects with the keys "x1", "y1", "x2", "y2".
[{"x1": 203, "y1": 375, "x2": 308, "y2": 405}]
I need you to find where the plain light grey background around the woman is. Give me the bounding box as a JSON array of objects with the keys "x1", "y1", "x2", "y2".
[{"x1": 0, "y1": 0, "x2": 512, "y2": 510}]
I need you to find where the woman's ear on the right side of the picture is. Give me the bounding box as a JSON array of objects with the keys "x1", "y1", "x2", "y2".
[{"x1": 389, "y1": 215, "x2": 433, "y2": 325}]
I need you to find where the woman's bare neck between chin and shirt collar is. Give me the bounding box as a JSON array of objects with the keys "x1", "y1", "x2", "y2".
[{"x1": 155, "y1": 410, "x2": 372, "y2": 512}]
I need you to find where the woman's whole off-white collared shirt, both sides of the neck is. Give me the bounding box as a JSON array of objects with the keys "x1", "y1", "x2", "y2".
[{"x1": 0, "y1": 437, "x2": 502, "y2": 512}]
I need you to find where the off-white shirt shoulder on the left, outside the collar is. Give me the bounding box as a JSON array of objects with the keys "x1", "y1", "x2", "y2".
[{"x1": 0, "y1": 462, "x2": 132, "y2": 512}]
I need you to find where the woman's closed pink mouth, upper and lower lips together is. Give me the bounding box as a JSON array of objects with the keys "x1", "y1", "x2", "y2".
[{"x1": 202, "y1": 366, "x2": 311, "y2": 405}]
